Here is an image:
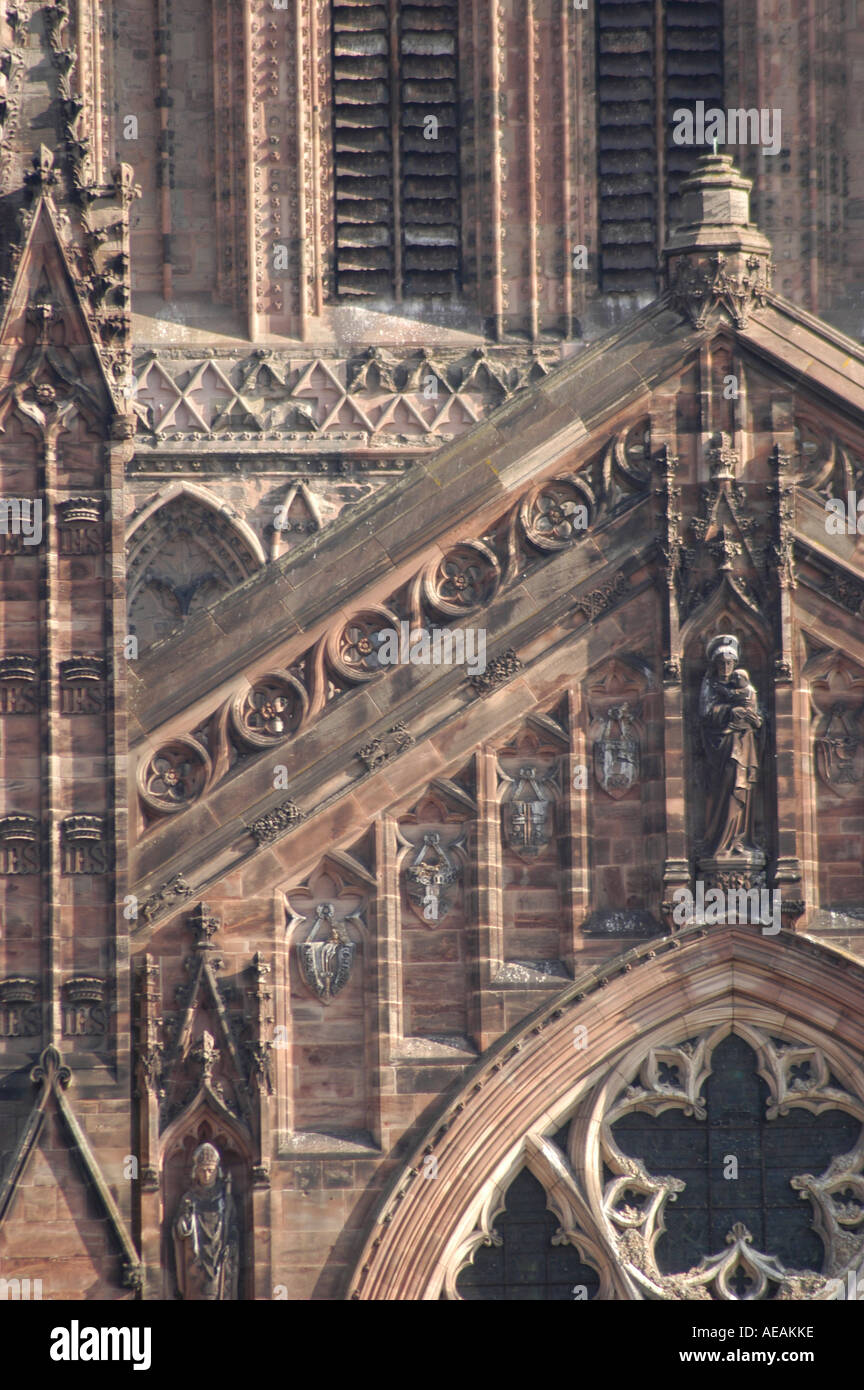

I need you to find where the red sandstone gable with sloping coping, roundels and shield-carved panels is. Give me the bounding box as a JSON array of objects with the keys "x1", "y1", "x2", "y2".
[{"x1": 129, "y1": 279, "x2": 864, "y2": 1297}]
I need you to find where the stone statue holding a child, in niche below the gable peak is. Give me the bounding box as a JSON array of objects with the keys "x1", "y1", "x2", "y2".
[{"x1": 699, "y1": 634, "x2": 763, "y2": 856}]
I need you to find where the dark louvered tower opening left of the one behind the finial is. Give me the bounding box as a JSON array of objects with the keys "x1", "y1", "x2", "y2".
[{"x1": 332, "y1": 0, "x2": 460, "y2": 300}]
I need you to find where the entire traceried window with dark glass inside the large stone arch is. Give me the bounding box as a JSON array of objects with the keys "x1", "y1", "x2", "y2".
[{"x1": 442, "y1": 1023, "x2": 864, "y2": 1302}]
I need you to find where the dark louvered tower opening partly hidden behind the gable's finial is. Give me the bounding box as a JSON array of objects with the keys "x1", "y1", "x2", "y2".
[{"x1": 596, "y1": 0, "x2": 724, "y2": 293}]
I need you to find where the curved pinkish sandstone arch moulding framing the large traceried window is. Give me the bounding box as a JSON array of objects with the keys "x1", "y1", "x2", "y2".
[{"x1": 347, "y1": 927, "x2": 864, "y2": 1301}]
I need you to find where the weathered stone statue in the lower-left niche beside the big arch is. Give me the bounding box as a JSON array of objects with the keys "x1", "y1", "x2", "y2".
[{"x1": 174, "y1": 1144, "x2": 240, "y2": 1302}]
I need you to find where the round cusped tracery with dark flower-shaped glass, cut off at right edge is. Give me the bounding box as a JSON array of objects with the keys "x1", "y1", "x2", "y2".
[{"x1": 588, "y1": 1026, "x2": 864, "y2": 1301}]
